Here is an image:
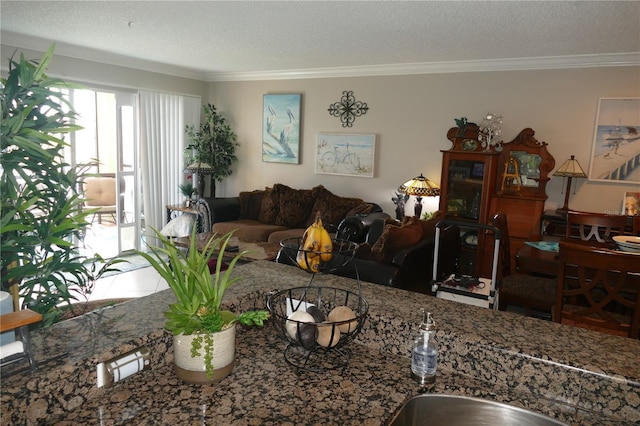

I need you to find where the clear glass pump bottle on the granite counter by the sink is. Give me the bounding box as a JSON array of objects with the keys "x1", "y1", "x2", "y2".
[{"x1": 411, "y1": 309, "x2": 438, "y2": 385}]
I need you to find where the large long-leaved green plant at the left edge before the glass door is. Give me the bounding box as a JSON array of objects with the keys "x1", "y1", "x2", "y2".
[{"x1": 0, "y1": 45, "x2": 116, "y2": 326}]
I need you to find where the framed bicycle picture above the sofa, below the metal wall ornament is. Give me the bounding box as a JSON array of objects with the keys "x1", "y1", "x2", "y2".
[{"x1": 316, "y1": 133, "x2": 376, "y2": 177}]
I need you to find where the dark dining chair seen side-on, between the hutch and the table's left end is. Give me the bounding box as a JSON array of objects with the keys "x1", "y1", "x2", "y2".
[{"x1": 491, "y1": 212, "x2": 556, "y2": 320}]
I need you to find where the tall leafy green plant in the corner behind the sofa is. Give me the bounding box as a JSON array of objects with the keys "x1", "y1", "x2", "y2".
[{"x1": 185, "y1": 104, "x2": 239, "y2": 197}]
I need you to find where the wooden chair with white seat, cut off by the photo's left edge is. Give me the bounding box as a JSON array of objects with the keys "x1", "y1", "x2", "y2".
[{"x1": 0, "y1": 309, "x2": 42, "y2": 372}]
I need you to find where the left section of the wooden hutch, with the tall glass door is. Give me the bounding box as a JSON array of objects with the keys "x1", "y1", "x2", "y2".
[{"x1": 440, "y1": 123, "x2": 500, "y2": 276}]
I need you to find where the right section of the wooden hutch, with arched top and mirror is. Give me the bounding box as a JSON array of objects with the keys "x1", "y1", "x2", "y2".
[{"x1": 490, "y1": 128, "x2": 555, "y2": 267}]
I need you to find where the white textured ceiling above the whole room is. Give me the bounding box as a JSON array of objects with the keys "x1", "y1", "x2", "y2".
[{"x1": 0, "y1": 0, "x2": 640, "y2": 79}]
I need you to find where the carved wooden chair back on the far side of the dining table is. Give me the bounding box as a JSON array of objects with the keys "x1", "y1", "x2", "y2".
[{"x1": 565, "y1": 211, "x2": 627, "y2": 243}]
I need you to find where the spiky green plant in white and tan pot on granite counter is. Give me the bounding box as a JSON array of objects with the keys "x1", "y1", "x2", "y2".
[{"x1": 138, "y1": 227, "x2": 269, "y2": 384}]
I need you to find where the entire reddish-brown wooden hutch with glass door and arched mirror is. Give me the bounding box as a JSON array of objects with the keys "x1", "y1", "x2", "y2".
[{"x1": 440, "y1": 123, "x2": 555, "y2": 276}]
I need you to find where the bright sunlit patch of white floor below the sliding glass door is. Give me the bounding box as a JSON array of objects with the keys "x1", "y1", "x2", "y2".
[{"x1": 89, "y1": 267, "x2": 169, "y2": 300}]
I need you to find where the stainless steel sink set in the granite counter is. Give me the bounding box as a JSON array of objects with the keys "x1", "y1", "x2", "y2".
[{"x1": 389, "y1": 394, "x2": 566, "y2": 426}]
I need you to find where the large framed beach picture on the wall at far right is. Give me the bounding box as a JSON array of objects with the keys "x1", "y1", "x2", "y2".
[{"x1": 589, "y1": 98, "x2": 640, "y2": 183}]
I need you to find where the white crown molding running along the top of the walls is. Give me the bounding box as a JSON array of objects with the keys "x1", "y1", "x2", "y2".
[{"x1": 1, "y1": 31, "x2": 640, "y2": 82}]
